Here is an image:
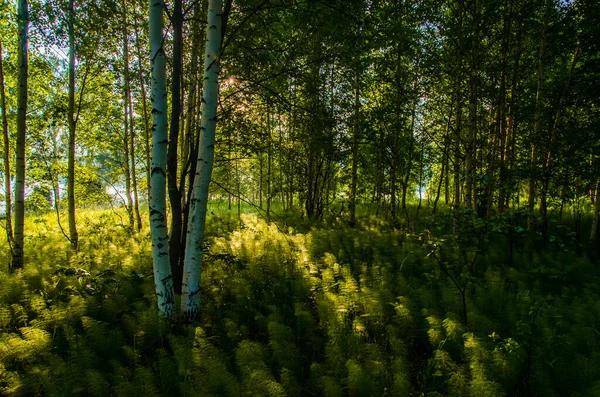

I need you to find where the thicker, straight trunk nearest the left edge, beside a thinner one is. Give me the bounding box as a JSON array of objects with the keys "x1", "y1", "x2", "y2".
[{"x1": 10, "y1": 0, "x2": 29, "y2": 272}]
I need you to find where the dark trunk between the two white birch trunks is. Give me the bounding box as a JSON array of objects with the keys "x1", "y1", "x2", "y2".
[{"x1": 167, "y1": 0, "x2": 185, "y2": 294}]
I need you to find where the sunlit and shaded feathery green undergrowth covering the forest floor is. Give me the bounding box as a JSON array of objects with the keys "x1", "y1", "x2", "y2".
[{"x1": 0, "y1": 208, "x2": 600, "y2": 397}]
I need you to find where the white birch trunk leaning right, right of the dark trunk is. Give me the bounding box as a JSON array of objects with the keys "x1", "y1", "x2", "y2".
[{"x1": 181, "y1": 0, "x2": 226, "y2": 319}]
